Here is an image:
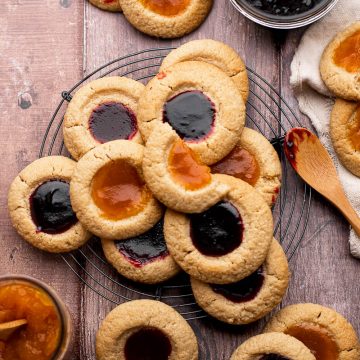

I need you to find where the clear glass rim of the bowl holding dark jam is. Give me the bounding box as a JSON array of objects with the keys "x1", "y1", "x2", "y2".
[{"x1": 230, "y1": 0, "x2": 338, "y2": 29}]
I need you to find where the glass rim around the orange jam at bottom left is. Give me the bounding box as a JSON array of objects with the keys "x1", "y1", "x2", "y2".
[{"x1": 0, "y1": 274, "x2": 73, "y2": 360}]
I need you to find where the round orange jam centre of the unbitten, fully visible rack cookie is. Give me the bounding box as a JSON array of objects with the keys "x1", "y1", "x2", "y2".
[{"x1": 91, "y1": 160, "x2": 151, "y2": 220}]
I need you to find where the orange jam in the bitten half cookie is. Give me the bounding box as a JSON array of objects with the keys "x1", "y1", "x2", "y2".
[{"x1": 168, "y1": 140, "x2": 211, "y2": 190}]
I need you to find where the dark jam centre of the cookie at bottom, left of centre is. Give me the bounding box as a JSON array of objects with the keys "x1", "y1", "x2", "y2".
[{"x1": 124, "y1": 326, "x2": 172, "y2": 360}]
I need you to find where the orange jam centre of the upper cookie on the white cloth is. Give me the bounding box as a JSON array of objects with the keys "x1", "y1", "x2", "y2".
[{"x1": 334, "y1": 30, "x2": 360, "y2": 73}]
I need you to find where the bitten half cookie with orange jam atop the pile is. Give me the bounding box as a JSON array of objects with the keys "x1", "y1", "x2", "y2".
[{"x1": 143, "y1": 124, "x2": 229, "y2": 213}]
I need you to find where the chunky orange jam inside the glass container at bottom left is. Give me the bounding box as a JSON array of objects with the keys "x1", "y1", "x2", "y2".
[{"x1": 0, "y1": 283, "x2": 62, "y2": 360}]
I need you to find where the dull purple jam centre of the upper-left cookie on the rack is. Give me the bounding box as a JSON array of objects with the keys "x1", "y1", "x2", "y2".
[{"x1": 89, "y1": 102, "x2": 137, "y2": 144}]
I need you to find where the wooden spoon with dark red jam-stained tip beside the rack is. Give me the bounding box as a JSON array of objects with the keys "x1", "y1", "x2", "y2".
[{"x1": 284, "y1": 128, "x2": 360, "y2": 236}]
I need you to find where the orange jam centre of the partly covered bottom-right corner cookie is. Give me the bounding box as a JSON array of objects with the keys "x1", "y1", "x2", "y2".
[{"x1": 286, "y1": 324, "x2": 339, "y2": 360}]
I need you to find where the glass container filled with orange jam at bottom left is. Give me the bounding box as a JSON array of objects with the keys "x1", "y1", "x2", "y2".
[{"x1": 0, "y1": 276, "x2": 71, "y2": 360}]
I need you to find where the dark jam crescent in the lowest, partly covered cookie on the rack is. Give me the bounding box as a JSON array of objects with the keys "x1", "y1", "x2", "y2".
[{"x1": 211, "y1": 267, "x2": 264, "y2": 303}]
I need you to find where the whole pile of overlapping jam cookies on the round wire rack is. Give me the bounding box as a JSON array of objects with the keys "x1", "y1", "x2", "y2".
[{"x1": 9, "y1": 40, "x2": 289, "y2": 324}]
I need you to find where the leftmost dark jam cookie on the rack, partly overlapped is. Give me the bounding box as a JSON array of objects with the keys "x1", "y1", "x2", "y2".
[{"x1": 8, "y1": 156, "x2": 90, "y2": 253}]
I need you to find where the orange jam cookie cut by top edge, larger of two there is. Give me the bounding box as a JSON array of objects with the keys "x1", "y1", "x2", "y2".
[{"x1": 120, "y1": 0, "x2": 213, "y2": 38}]
